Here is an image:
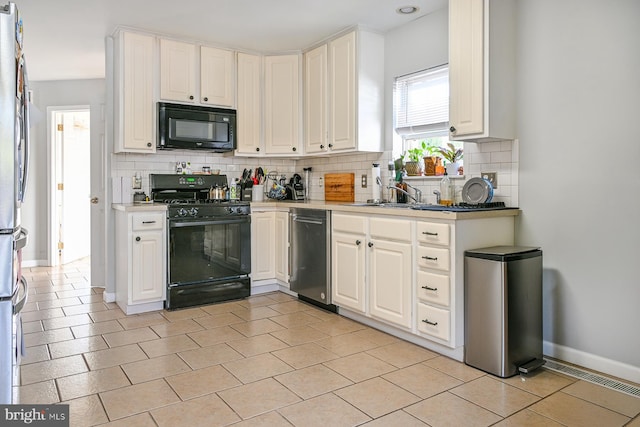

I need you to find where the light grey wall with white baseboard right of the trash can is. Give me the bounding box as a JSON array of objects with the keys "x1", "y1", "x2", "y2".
[{"x1": 517, "y1": 0, "x2": 640, "y2": 382}]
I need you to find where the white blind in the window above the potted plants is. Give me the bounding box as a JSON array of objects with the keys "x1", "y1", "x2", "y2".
[{"x1": 393, "y1": 65, "x2": 449, "y2": 135}]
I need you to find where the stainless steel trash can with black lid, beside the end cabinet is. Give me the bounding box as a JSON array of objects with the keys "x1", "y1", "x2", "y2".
[{"x1": 464, "y1": 246, "x2": 544, "y2": 378}]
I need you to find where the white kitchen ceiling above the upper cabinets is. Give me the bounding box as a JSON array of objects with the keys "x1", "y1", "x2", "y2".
[{"x1": 14, "y1": 0, "x2": 448, "y2": 81}]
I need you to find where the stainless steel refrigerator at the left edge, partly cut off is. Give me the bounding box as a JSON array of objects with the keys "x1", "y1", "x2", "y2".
[{"x1": 0, "y1": 3, "x2": 29, "y2": 404}]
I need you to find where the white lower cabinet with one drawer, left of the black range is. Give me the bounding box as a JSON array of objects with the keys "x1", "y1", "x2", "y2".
[{"x1": 116, "y1": 210, "x2": 166, "y2": 314}]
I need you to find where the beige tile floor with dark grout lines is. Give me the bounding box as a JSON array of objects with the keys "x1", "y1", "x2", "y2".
[{"x1": 16, "y1": 260, "x2": 640, "y2": 427}]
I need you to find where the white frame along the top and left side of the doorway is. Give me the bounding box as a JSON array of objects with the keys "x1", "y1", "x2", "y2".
[{"x1": 47, "y1": 104, "x2": 91, "y2": 267}]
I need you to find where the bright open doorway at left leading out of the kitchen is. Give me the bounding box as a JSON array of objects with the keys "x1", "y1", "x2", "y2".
[{"x1": 49, "y1": 106, "x2": 91, "y2": 266}]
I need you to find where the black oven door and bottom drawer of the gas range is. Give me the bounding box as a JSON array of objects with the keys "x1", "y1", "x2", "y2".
[{"x1": 167, "y1": 216, "x2": 251, "y2": 309}]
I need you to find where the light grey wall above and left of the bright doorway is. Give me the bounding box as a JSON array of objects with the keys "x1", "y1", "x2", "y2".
[{"x1": 22, "y1": 79, "x2": 105, "y2": 265}]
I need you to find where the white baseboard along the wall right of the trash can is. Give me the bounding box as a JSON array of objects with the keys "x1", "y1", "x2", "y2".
[{"x1": 542, "y1": 341, "x2": 640, "y2": 383}]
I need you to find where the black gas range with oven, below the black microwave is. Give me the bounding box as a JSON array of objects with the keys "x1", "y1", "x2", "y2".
[{"x1": 149, "y1": 174, "x2": 251, "y2": 310}]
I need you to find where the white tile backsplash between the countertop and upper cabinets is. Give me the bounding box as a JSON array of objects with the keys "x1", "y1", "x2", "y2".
[{"x1": 111, "y1": 140, "x2": 518, "y2": 206}]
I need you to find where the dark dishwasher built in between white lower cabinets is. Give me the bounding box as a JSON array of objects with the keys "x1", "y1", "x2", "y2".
[{"x1": 289, "y1": 208, "x2": 336, "y2": 312}]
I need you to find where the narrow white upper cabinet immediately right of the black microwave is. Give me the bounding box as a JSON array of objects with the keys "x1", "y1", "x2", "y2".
[{"x1": 236, "y1": 53, "x2": 264, "y2": 155}]
